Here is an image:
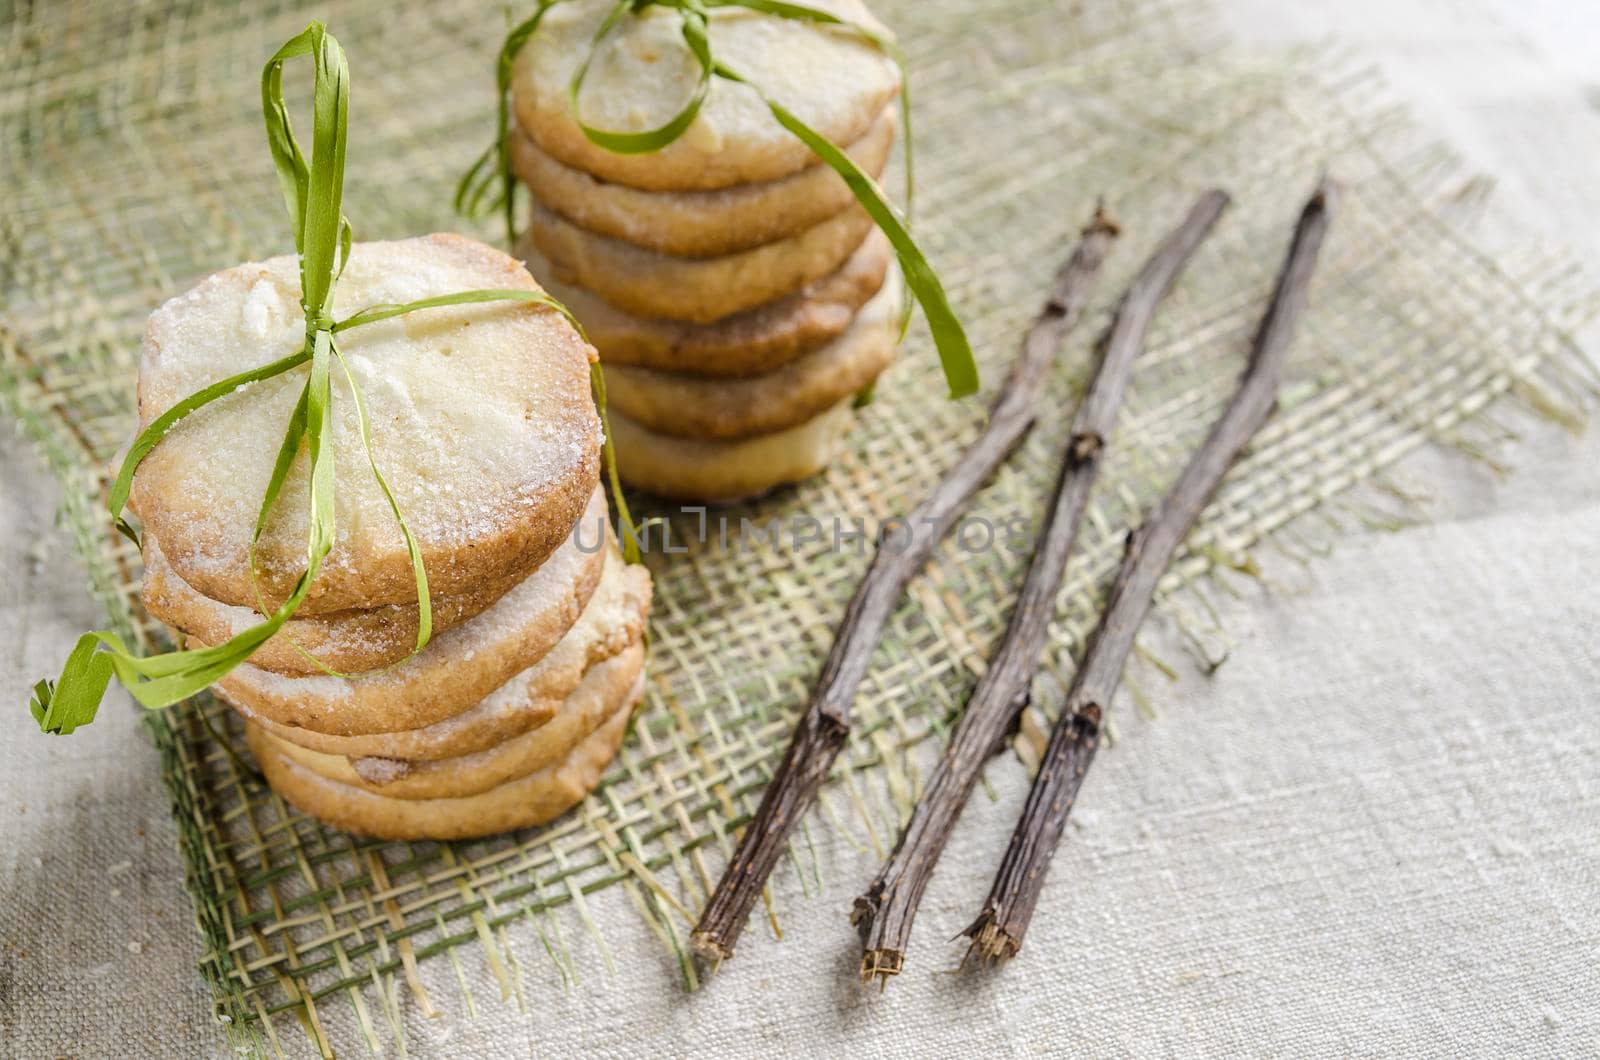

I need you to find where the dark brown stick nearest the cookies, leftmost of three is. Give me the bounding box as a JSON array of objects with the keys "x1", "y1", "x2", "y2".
[{"x1": 691, "y1": 208, "x2": 1117, "y2": 961}]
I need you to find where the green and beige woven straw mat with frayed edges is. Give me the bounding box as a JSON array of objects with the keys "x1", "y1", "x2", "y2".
[{"x1": 0, "y1": 0, "x2": 1595, "y2": 1050}]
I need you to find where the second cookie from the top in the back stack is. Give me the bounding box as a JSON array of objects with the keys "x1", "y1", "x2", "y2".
[{"x1": 510, "y1": 107, "x2": 896, "y2": 258}]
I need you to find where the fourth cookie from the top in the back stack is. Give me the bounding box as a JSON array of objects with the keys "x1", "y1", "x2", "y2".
[{"x1": 517, "y1": 229, "x2": 894, "y2": 378}]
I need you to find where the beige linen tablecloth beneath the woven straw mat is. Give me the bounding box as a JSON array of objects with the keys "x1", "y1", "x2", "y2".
[{"x1": 0, "y1": 0, "x2": 1600, "y2": 1058}]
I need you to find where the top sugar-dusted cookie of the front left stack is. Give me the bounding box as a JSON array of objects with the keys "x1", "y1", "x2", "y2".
[{"x1": 131, "y1": 235, "x2": 600, "y2": 616}]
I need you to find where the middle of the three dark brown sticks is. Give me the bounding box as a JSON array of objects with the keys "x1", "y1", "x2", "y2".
[{"x1": 851, "y1": 191, "x2": 1227, "y2": 982}]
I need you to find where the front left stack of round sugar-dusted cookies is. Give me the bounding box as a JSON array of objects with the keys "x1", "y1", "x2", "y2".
[{"x1": 133, "y1": 235, "x2": 650, "y2": 839}]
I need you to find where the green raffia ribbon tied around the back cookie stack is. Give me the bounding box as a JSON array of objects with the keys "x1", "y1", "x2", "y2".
[{"x1": 456, "y1": 0, "x2": 978, "y2": 397}]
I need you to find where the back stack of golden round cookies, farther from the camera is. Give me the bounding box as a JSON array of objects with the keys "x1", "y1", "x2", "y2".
[{"x1": 509, "y1": 0, "x2": 902, "y2": 500}]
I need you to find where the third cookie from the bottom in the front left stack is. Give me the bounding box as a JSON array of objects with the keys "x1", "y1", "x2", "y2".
[{"x1": 233, "y1": 547, "x2": 651, "y2": 762}]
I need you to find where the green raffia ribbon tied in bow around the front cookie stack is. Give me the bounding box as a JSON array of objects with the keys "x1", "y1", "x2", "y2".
[{"x1": 29, "y1": 22, "x2": 624, "y2": 733}]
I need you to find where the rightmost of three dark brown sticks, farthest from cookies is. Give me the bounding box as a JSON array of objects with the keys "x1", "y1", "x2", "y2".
[{"x1": 963, "y1": 179, "x2": 1338, "y2": 961}]
